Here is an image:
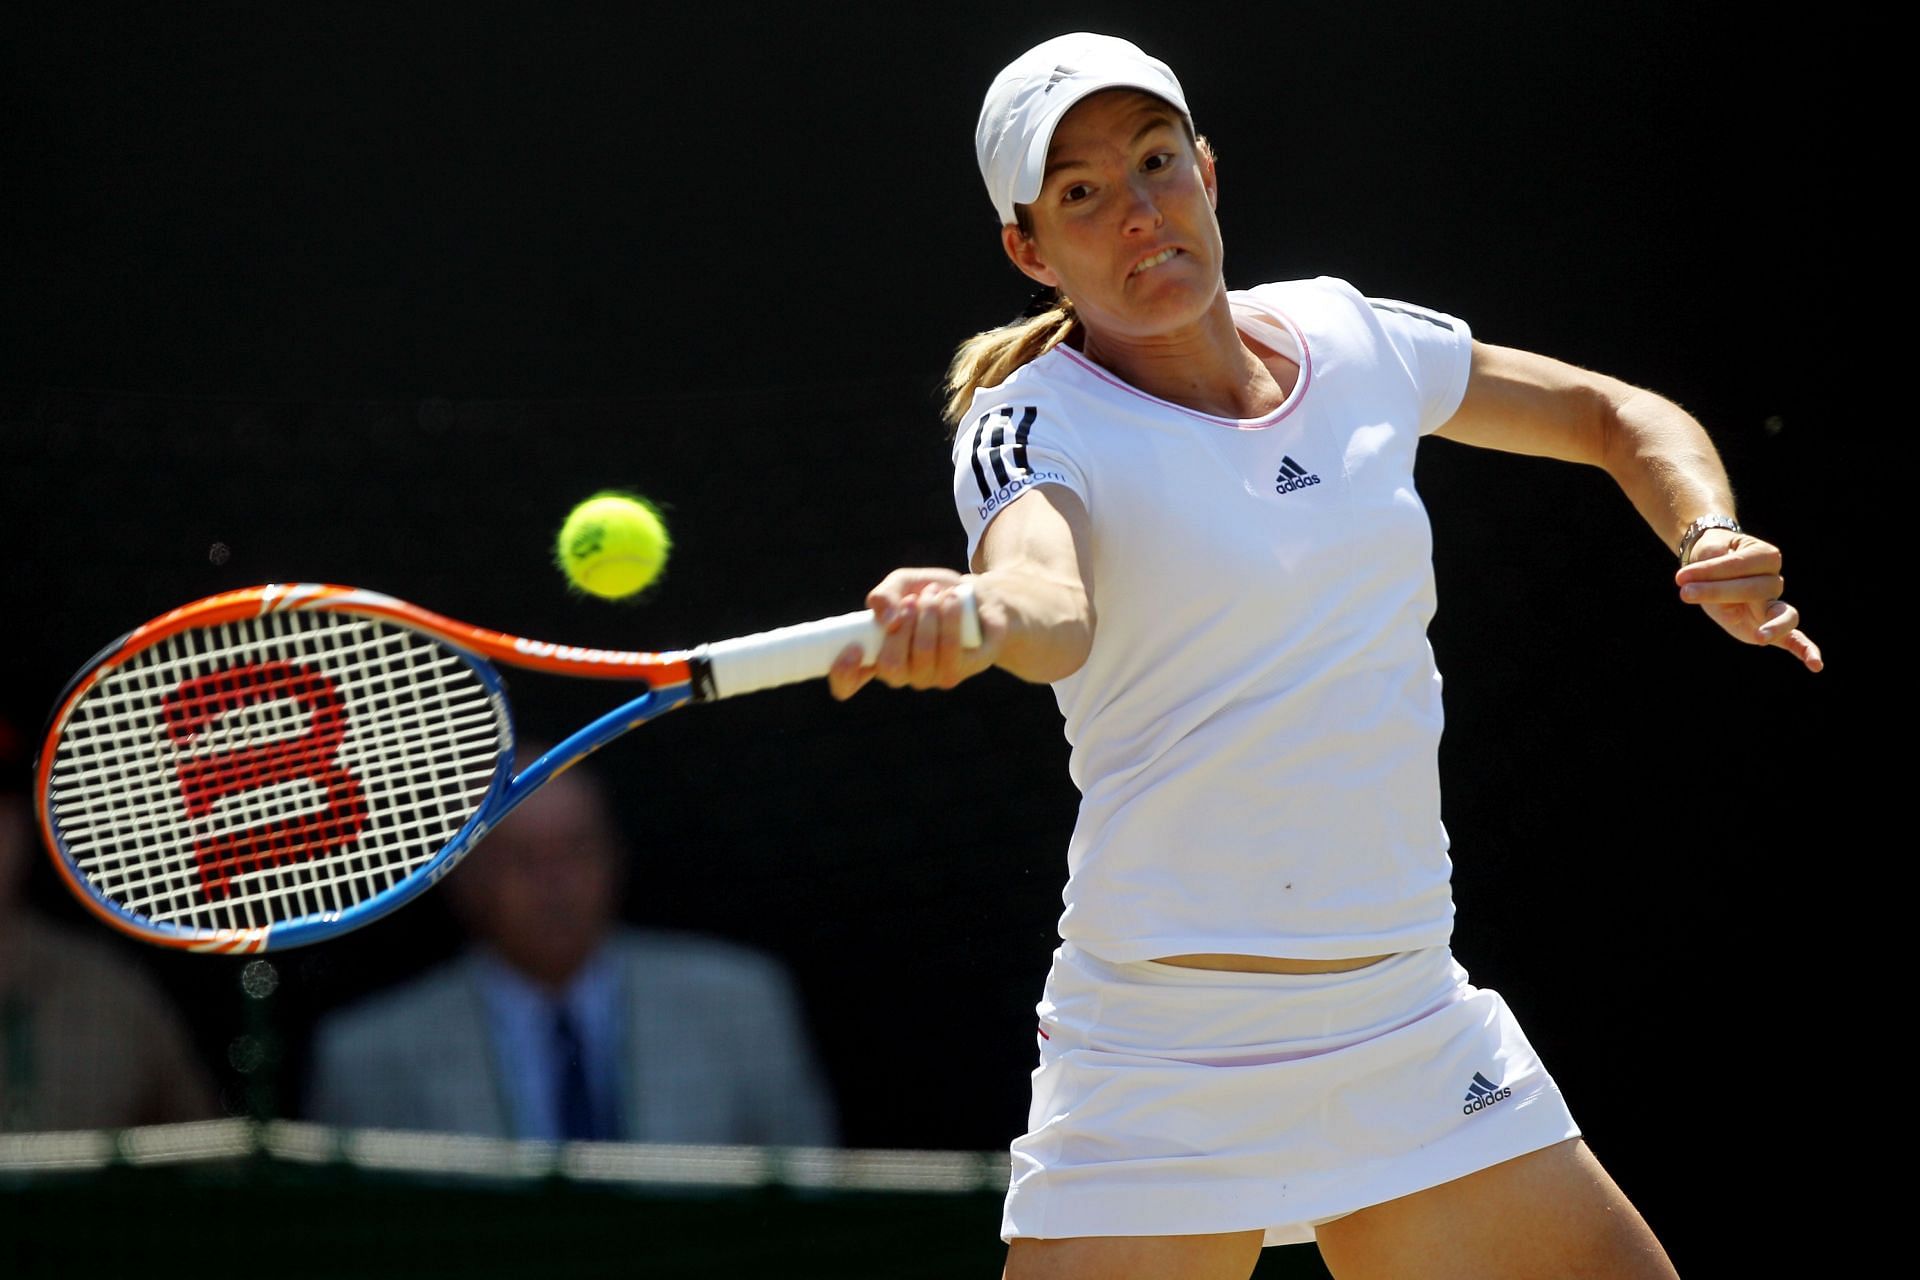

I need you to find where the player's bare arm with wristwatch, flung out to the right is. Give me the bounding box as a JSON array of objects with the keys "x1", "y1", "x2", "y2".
[{"x1": 1438, "y1": 342, "x2": 1822, "y2": 672}]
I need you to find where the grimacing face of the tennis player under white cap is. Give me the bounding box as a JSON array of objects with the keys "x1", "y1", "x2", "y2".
[{"x1": 1002, "y1": 90, "x2": 1225, "y2": 338}]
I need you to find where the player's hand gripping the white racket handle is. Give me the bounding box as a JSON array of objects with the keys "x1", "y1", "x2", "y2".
[{"x1": 828, "y1": 568, "x2": 1004, "y2": 699}]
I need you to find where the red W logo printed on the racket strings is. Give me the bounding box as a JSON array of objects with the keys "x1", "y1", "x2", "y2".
[{"x1": 159, "y1": 662, "x2": 367, "y2": 902}]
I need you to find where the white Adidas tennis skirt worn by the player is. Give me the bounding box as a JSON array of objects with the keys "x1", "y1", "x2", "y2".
[{"x1": 1000, "y1": 942, "x2": 1580, "y2": 1245}]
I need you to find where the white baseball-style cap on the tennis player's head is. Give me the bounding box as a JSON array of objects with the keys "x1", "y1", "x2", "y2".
[{"x1": 973, "y1": 31, "x2": 1192, "y2": 223}]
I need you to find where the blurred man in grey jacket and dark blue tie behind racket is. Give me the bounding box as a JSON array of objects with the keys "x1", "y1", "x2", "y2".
[{"x1": 307, "y1": 748, "x2": 835, "y2": 1146}]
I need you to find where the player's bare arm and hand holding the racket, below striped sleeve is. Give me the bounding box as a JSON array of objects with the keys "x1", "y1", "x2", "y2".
[{"x1": 828, "y1": 486, "x2": 1094, "y2": 699}]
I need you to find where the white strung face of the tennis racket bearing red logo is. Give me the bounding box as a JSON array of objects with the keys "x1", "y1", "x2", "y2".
[{"x1": 48, "y1": 612, "x2": 507, "y2": 931}]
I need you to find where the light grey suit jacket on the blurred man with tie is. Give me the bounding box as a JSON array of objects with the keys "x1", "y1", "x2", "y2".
[{"x1": 307, "y1": 929, "x2": 837, "y2": 1146}]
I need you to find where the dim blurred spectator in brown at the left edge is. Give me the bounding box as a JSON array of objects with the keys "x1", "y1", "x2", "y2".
[{"x1": 0, "y1": 720, "x2": 221, "y2": 1132}]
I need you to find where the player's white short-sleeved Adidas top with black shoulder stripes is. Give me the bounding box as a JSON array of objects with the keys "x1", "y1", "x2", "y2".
[{"x1": 954, "y1": 276, "x2": 1473, "y2": 961}]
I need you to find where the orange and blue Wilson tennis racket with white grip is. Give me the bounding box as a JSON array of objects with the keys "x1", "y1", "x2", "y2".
[{"x1": 35, "y1": 583, "x2": 979, "y2": 954}]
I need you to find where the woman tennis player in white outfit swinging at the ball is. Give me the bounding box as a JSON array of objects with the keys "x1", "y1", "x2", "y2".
[{"x1": 831, "y1": 33, "x2": 1820, "y2": 1280}]
